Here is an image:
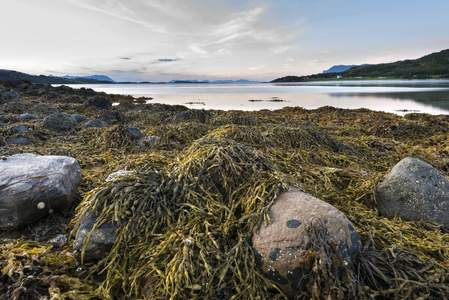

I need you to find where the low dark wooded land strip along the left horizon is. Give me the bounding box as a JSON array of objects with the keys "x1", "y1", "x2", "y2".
[{"x1": 0, "y1": 69, "x2": 114, "y2": 84}]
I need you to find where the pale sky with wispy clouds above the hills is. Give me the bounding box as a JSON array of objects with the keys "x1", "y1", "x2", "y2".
[{"x1": 0, "y1": 0, "x2": 449, "y2": 81}]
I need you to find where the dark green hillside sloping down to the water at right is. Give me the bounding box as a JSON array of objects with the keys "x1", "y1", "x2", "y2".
[{"x1": 271, "y1": 49, "x2": 449, "y2": 82}]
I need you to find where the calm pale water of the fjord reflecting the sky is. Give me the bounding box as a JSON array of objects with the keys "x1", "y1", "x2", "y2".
[{"x1": 63, "y1": 80, "x2": 449, "y2": 114}]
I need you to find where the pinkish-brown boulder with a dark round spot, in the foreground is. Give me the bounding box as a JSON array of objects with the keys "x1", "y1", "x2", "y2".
[{"x1": 253, "y1": 188, "x2": 361, "y2": 299}]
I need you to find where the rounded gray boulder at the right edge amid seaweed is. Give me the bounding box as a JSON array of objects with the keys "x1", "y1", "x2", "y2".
[{"x1": 376, "y1": 157, "x2": 449, "y2": 228}]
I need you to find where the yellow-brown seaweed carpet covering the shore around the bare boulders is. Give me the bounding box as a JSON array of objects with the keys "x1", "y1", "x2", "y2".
[{"x1": 0, "y1": 82, "x2": 449, "y2": 299}]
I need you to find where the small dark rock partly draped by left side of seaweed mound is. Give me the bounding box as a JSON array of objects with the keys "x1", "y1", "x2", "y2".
[{"x1": 73, "y1": 214, "x2": 118, "y2": 263}]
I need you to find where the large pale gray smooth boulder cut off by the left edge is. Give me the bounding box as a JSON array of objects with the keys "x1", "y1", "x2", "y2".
[{"x1": 0, "y1": 153, "x2": 82, "y2": 229}]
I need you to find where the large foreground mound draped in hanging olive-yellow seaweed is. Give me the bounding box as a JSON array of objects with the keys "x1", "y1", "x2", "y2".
[{"x1": 69, "y1": 138, "x2": 287, "y2": 299}]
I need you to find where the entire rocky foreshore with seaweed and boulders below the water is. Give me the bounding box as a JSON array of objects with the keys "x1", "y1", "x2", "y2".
[{"x1": 0, "y1": 81, "x2": 449, "y2": 299}]
